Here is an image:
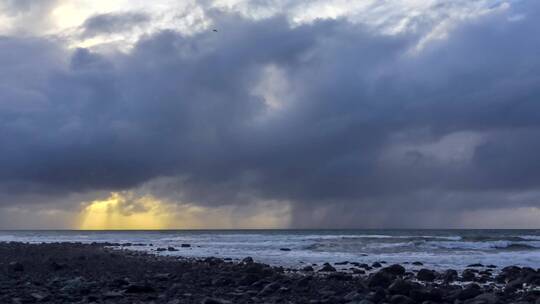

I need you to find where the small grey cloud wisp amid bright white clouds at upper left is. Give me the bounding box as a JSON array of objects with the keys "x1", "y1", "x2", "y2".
[{"x1": 81, "y1": 13, "x2": 150, "y2": 38}]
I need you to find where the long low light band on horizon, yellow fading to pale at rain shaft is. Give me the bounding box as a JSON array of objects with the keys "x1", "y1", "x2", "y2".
[{"x1": 73, "y1": 191, "x2": 290, "y2": 230}]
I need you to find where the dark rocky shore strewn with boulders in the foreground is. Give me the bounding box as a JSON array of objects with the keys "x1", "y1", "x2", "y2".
[{"x1": 0, "y1": 243, "x2": 540, "y2": 304}]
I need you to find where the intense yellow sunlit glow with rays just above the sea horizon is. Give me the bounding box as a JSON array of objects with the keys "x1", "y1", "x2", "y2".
[{"x1": 79, "y1": 192, "x2": 170, "y2": 230}]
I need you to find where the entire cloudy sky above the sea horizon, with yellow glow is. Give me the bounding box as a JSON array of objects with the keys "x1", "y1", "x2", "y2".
[{"x1": 0, "y1": 0, "x2": 540, "y2": 229}]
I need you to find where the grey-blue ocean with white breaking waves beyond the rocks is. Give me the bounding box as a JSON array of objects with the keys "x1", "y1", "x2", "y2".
[{"x1": 0, "y1": 230, "x2": 540, "y2": 270}]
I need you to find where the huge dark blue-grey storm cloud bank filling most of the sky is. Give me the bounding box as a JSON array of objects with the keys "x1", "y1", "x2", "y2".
[{"x1": 0, "y1": 2, "x2": 540, "y2": 226}]
